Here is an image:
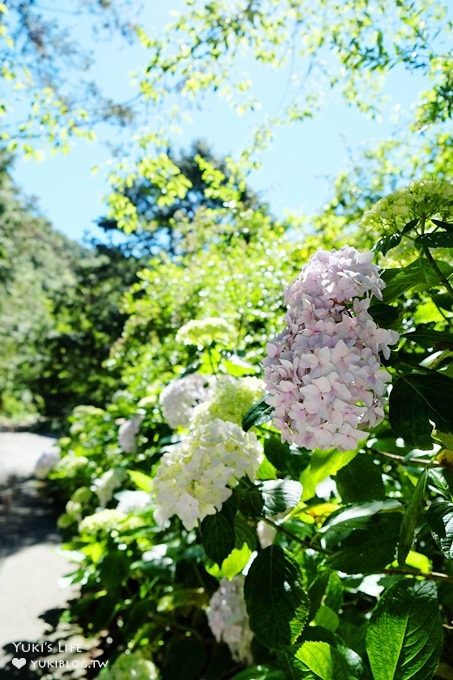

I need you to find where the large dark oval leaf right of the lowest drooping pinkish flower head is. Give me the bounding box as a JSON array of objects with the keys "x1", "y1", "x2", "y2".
[{"x1": 244, "y1": 545, "x2": 310, "y2": 649}]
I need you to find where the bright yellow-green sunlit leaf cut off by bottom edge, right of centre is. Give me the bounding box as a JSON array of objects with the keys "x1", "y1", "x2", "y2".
[{"x1": 296, "y1": 641, "x2": 352, "y2": 680}]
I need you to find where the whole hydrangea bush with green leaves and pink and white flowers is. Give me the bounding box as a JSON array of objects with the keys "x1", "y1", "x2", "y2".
[{"x1": 44, "y1": 182, "x2": 453, "y2": 680}]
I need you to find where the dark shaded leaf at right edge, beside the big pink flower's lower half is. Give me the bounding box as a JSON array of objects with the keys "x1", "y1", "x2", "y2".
[{"x1": 389, "y1": 371, "x2": 453, "y2": 448}]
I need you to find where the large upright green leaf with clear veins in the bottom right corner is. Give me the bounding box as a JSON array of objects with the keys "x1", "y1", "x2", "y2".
[{"x1": 367, "y1": 579, "x2": 442, "y2": 680}]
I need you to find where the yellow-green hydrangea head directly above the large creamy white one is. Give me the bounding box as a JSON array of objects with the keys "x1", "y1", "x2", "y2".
[{"x1": 192, "y1": 375, "x2": 266, "y2": 425}]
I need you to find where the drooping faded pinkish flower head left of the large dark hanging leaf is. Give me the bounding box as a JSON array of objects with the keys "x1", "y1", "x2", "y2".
[{"x1": 207, "y1": 576, "x2": 253, "y2": 664}]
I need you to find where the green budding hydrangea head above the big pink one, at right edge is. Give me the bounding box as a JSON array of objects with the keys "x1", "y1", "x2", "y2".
[{"x1": 361, "y1": 180, "x2": 453, "y2": 231}]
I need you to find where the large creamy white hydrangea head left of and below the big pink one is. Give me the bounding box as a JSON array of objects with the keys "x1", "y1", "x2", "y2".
[{"x1": 153, "y1": 418, "x2": 262, "y2": 530}]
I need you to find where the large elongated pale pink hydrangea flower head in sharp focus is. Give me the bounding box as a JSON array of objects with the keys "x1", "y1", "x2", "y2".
[{"x1": 265, "y1": 247, "x2": 398, "y2": 450}]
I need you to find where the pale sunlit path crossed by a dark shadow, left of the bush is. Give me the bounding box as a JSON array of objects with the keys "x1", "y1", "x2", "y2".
[{"x1": 0, "y1": 432, "x2": 97, "y2": 680}]
